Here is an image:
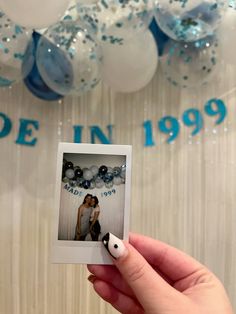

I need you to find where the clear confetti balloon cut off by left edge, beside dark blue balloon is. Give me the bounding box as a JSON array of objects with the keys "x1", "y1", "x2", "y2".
[{"x1": 0, "y1": 12, "x2": 32, "y2": 86}]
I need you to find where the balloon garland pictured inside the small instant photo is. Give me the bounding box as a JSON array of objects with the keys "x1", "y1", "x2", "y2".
[{"x1": 62, "y1": 160, "x2": 126, "y2": 190}]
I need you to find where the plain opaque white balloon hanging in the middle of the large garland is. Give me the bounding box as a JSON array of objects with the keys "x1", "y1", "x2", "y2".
[{"x1": 102, "y1": 30, "x2": 158, "y2": 93}]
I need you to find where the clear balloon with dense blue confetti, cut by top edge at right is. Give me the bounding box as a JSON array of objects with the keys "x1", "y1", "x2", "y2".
[{"x1": 155, "y1": 0, "x2": 226, "y2": 42}]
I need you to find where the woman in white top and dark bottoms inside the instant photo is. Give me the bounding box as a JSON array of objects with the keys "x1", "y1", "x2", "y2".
[{"x1": 90, "y1": 196, "x2": 101, "y2": 241}]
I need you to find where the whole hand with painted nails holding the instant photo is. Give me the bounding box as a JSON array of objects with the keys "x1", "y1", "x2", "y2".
[{"x1": 88, "y1": 234, "x2": 233, "y2": 314}]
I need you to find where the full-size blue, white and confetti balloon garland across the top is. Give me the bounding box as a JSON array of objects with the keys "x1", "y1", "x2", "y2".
[{"x1": 0, "y1": 0, "x2": 236, "y2": 101}]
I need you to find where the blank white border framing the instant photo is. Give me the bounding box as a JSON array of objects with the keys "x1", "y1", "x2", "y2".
[{"x1": 51, "y1": 143, "x2": 132, "y2": 264}]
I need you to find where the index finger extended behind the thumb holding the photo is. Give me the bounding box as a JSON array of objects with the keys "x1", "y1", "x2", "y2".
[{"x1": 129, "y1": 233, "x2": 204, "y2": 282}]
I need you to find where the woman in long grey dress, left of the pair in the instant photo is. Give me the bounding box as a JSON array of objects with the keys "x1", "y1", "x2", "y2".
[{"x1": 74, "y1": 194, "x2": 92, "y2": 241}]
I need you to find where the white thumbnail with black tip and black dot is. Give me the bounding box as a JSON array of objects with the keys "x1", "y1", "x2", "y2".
[{"x1": 102, "y1": 232, "x2": 127, "y2": 259}]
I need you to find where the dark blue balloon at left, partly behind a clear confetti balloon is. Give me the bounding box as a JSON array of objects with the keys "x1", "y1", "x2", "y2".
[{"x1": 22, "y1": 32, "x2": 63, "y2": 101}]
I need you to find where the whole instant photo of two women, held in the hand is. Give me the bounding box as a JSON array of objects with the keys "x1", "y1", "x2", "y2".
[{"x1": 52, "y1": 143, "x2": 132, "y2": 264}]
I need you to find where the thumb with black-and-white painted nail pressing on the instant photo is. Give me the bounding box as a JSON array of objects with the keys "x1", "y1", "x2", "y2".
[{"x1": 102, "y1": 233, "x2": 180, "y2": 313}]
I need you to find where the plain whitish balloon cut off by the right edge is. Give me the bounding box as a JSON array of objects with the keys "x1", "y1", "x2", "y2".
[{"x1": 218, "y1": 8, "x2": 236, "y2": 65}]
